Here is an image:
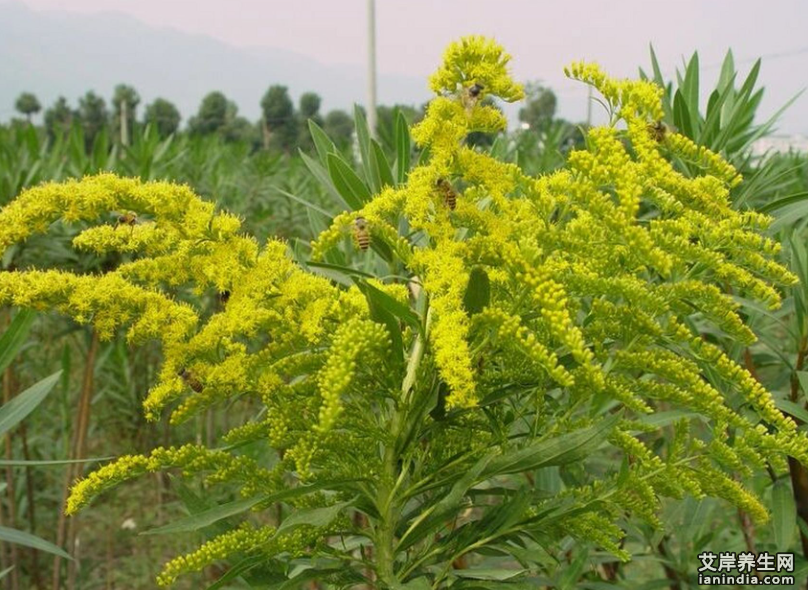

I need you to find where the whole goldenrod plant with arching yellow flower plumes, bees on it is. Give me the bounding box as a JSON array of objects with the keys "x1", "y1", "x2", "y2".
[{"x1": 0, "y1": 37, "x2": 808, "y2": 590}]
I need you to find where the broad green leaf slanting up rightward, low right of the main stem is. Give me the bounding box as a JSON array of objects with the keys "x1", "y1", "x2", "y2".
[{"x1": 485, "y1": 414, "x2": 620, "y2": 478}]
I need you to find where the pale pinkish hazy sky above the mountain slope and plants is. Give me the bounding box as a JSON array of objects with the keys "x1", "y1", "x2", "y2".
[{"x1": 12, "y1": 0, "x2": 808, "y2": 132}]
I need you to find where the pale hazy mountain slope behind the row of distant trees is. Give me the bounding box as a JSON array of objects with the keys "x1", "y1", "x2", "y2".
[{"x1": 0, "y1": 0, "x2": 430, "y2": 121}]
